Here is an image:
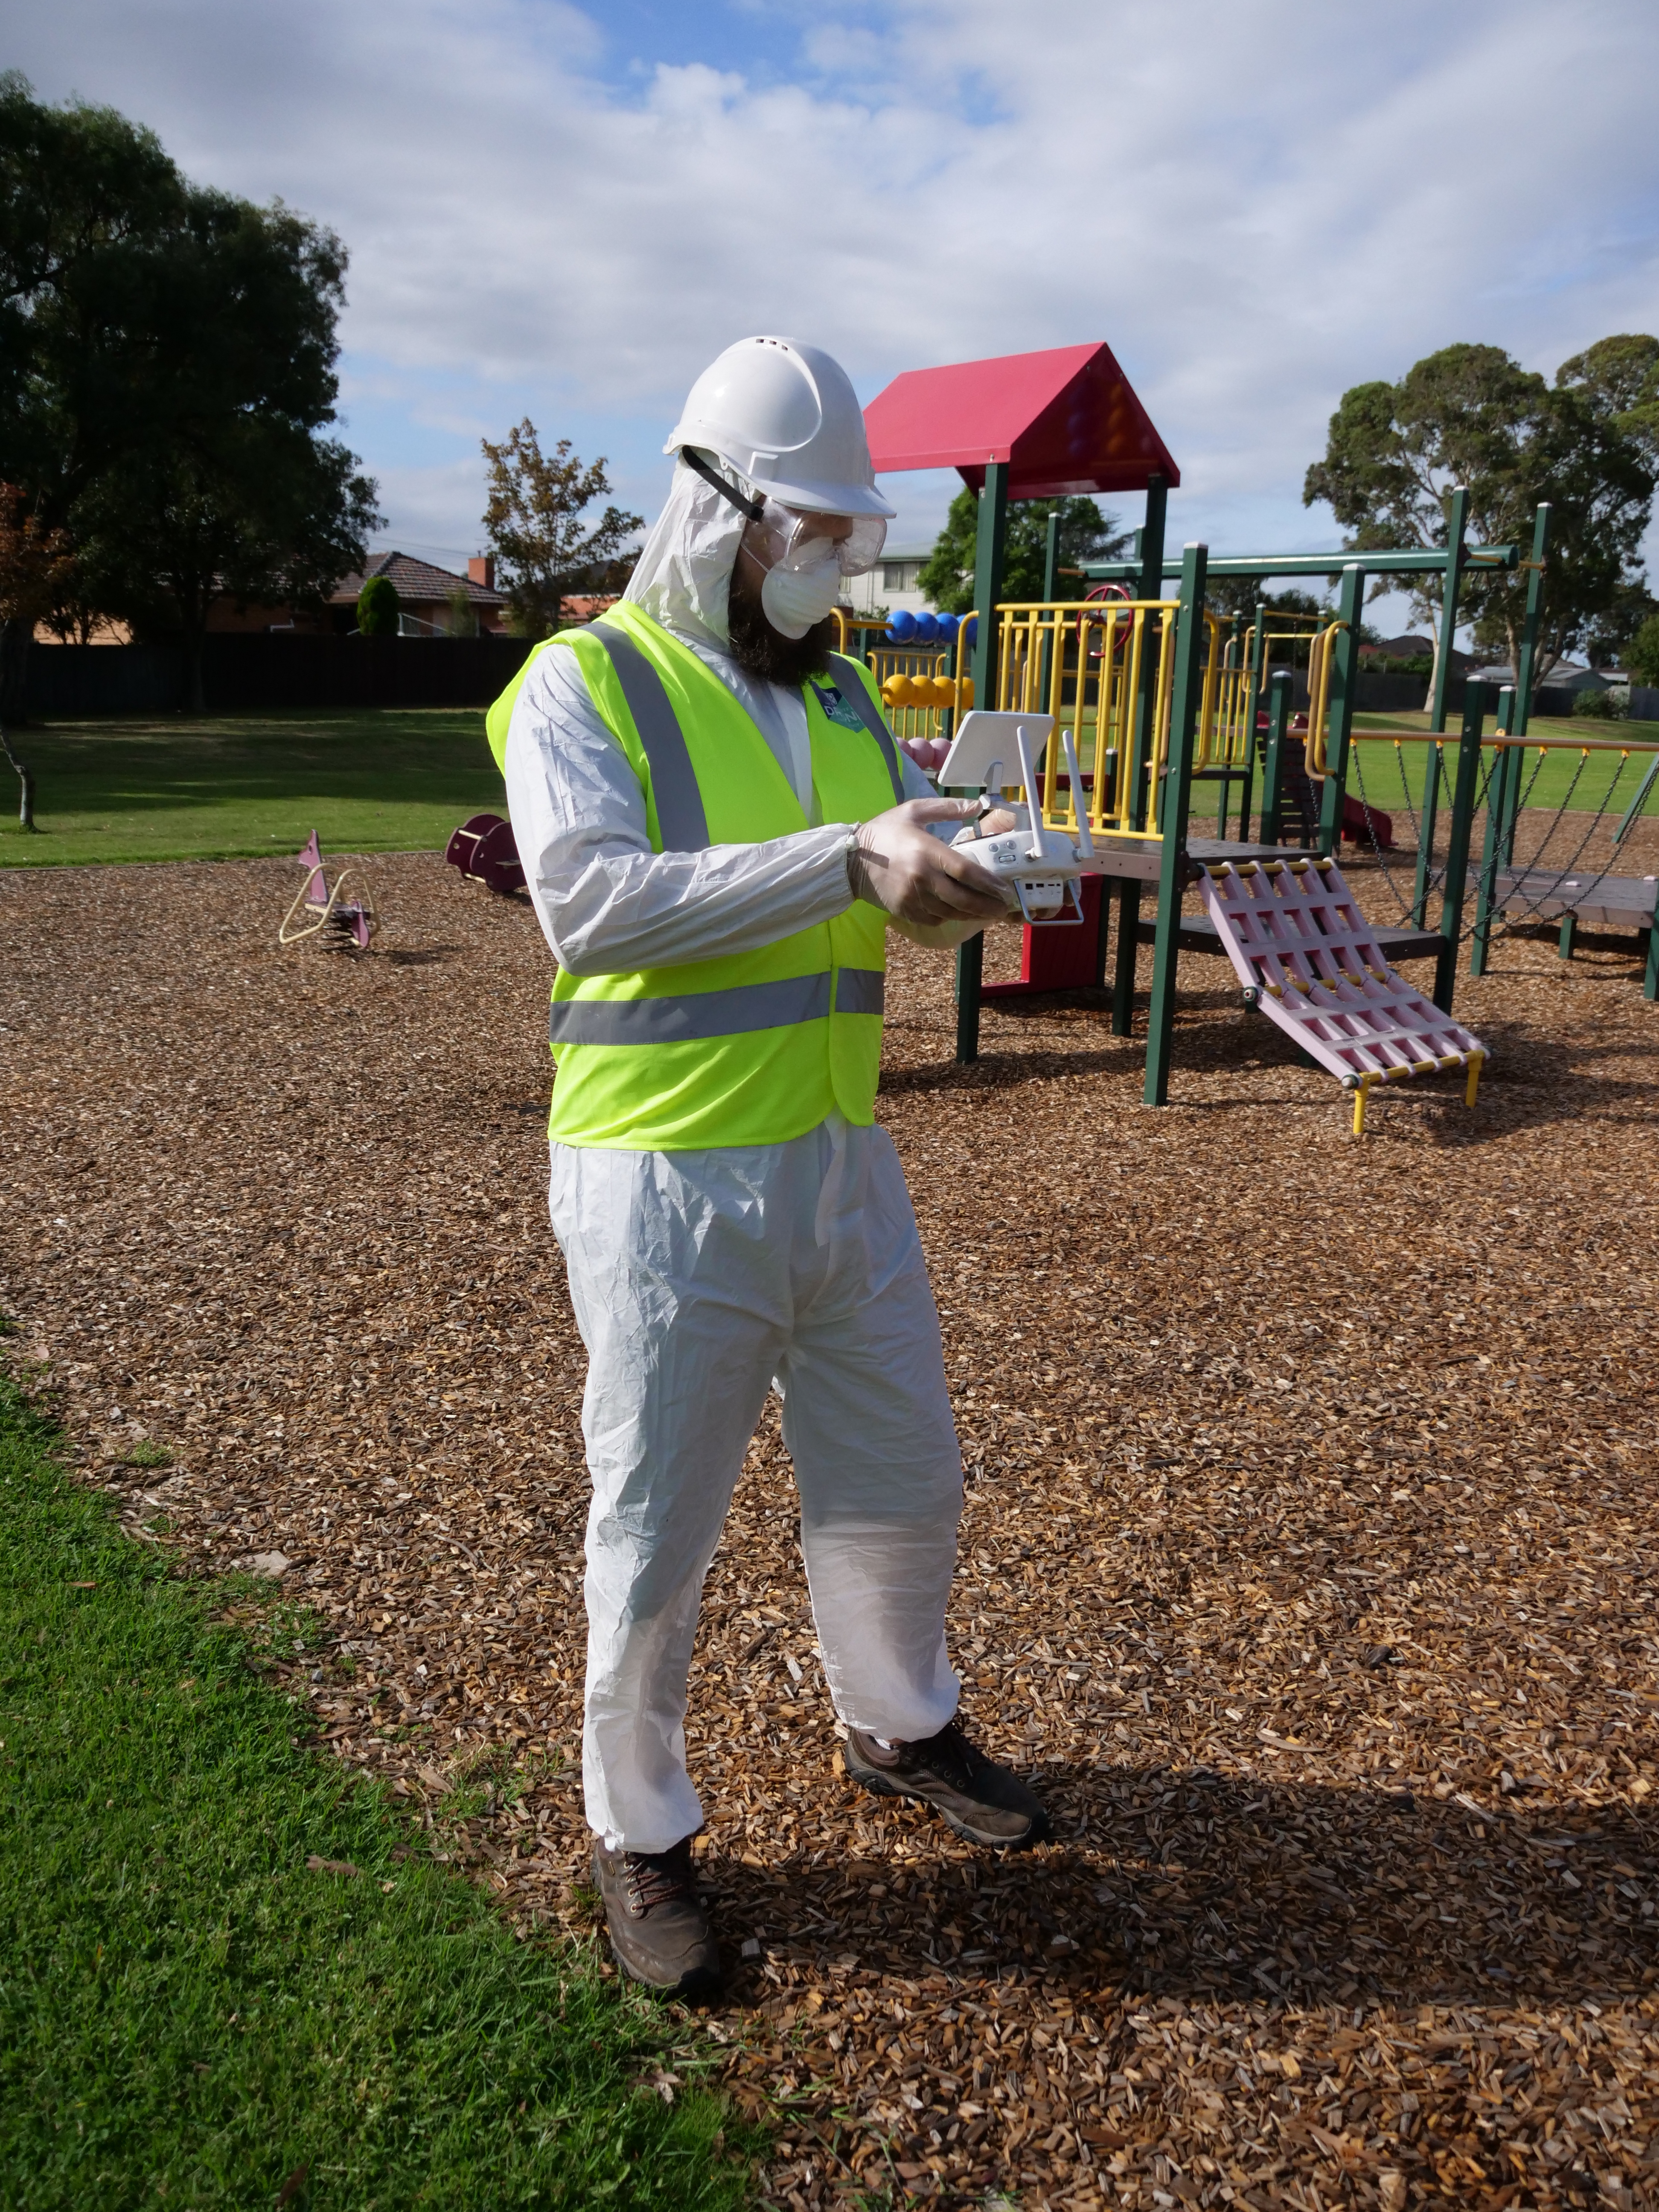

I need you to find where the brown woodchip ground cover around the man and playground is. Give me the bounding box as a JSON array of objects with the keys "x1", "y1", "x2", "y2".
[{"x1": 0, "y1": 825, "x2": 1659, "y2": 2212}]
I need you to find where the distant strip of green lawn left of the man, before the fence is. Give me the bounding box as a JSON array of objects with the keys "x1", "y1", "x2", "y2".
[{"x1": 0, "y1": 708, "x2": 506, "y2": 867}]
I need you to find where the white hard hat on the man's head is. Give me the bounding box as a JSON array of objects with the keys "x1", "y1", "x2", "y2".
[{"x1": 664, "y1": 338, "x2": 896, "y2": 515}]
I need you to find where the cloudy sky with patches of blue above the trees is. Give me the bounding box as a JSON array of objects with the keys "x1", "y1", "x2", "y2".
[{"x1": 0, "y1": 0, "x2": 1659, "y2": 628}]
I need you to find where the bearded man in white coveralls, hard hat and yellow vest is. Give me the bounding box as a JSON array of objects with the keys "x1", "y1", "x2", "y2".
[{"x1": 491, "y1": 338, "x2": 1048, "y2": 1997}]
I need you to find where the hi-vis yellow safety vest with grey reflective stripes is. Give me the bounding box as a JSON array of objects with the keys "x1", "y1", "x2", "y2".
[{"x1": 489, "y1": 600, "x2": 905, "y2": 1153}]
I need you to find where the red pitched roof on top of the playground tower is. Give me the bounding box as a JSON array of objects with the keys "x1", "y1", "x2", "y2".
[{"x1": 865, "y1": 345, "x2": 1181, "y2": 500}]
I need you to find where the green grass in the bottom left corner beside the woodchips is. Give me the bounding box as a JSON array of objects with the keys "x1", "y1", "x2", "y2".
[{"x1": 0, "y1": 1376, "x2": 759, "y2": 2212}]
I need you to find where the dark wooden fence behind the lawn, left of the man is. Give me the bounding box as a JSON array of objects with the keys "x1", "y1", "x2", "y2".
[{"x1": 26, "y1": 630, "x2": 531, "y2": 719}]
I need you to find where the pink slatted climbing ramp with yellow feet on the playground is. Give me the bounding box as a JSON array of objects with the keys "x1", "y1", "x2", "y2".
[{"x1": 1199, "y1": 861, "x2": 1487, "y2": 1135}]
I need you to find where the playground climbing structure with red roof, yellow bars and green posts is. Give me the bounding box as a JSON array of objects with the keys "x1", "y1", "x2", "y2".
[{"x1": 865, "y1": 345, "x2": 1659, "y2": 1128}]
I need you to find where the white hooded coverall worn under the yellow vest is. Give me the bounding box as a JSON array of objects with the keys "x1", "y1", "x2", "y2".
[{"x1": 506, "y1": 467, "x2": 962, "y2": 1851}]
